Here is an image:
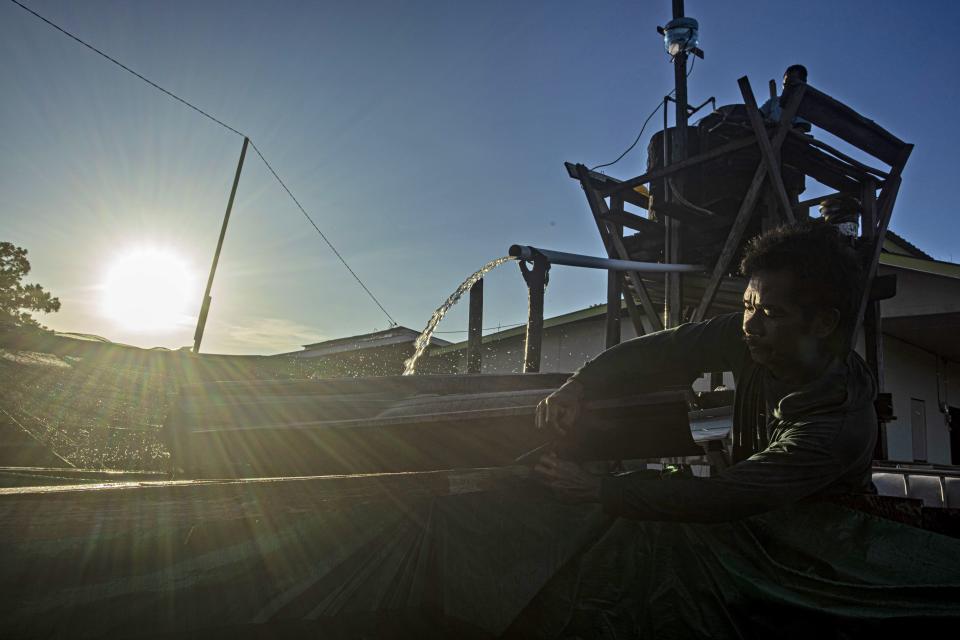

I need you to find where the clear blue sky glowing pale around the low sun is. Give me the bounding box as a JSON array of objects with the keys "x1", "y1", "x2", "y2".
[{"x1": 0, "y1": 0, "x2": 960, "y2": 353}]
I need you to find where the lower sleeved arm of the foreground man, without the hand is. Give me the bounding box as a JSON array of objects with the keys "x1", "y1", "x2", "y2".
[{"x1": 600, "y1": 418, "x2": 847, "y2": 522}]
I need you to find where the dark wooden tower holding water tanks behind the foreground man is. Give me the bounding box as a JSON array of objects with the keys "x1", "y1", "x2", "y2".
[{"x1": 567, "y1": 7, "x2": 913, "y2": 457}]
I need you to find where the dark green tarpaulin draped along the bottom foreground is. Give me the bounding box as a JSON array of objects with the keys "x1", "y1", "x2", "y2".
[{"x1": 0, "y1": 479, "x2": 960, "y2": 638}]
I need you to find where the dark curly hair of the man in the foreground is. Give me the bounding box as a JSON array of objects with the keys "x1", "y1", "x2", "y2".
[{"x1": 740, "y1": 221, "x2": 862, "y2": 349}]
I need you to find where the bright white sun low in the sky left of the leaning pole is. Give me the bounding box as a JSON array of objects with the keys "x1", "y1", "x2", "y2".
[{"x1": 103, "y1": 249, "x2": 199, "y2": 331}]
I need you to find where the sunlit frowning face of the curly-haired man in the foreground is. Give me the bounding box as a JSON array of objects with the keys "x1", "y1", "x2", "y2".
[{"x1": 743, "y1": 271, "x2": 823, "y2": 370}]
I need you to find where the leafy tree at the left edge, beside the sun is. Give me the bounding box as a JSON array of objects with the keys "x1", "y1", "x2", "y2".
[{"x1": 0, "y1": 242, "x2": 60, "y2": 330}]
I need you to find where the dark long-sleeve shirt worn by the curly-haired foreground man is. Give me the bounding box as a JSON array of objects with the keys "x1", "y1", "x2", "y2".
[{"x1": 574, "y1": 313, "x2": 877, "y2": 522}]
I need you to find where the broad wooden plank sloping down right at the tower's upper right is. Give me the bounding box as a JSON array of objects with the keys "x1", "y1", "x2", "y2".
[{"x1": 798, "y1": 85, "x2": 906, "y2": 166}]
